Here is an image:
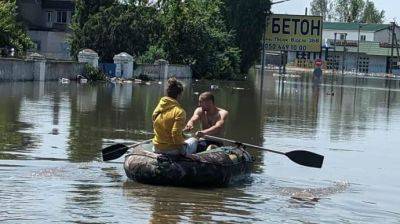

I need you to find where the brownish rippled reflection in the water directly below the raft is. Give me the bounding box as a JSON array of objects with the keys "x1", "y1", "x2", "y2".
[{"x1": 123, "y1": 181, "x2": 261, "y2": 224}]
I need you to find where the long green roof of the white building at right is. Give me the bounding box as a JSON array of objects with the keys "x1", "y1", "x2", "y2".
[{"x1": 323, "y1": 22, "x2": 391, "y2": 32}]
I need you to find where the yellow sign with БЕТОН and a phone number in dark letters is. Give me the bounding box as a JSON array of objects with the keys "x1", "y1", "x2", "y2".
[{"x1": 265, "y1": 14, "x2": 322, "y2": 52}]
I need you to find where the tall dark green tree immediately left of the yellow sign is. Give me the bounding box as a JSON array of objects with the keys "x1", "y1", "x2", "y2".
[{"x1": 223, "y1": 0, "x2": 271, "y2": 73}]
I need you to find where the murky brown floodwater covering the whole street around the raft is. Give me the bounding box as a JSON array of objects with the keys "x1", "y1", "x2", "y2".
[{"x1": 0, "y1": 74, "x2": 400, "y2": 223}]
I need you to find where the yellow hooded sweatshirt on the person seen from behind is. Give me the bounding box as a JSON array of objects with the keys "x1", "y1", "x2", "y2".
[{"x1": 153, "y1": 96, "x2": 186, "y2": 152}]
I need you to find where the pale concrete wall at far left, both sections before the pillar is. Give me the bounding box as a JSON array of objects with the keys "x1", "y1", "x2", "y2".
[{"x1": 0, "y1": 58, "x2": 85, "y2": 81}]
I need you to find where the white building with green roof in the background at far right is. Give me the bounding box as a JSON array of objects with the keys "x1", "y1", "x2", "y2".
[{"x1": 288, "y1": 22, "x2": 400, "y2": 73}]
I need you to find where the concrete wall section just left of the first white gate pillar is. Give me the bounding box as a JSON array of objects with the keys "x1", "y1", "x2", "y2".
[{"x1": 45, "y1": 61, "x2": 85, "y2": 80}]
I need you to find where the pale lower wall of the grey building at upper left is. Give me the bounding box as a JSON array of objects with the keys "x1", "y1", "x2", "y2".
[{"x1": 28, "y1": 30, "x2": 71, "y2": 60}]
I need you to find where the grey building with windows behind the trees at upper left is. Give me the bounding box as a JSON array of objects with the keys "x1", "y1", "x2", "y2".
[{"x1": 17, "y1": 0, "x2": 75, "y2": 59}]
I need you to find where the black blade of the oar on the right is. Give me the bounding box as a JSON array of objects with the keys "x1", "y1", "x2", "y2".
[{"x1": 285, "y1": 150, "x2": 324, "y2": 168}]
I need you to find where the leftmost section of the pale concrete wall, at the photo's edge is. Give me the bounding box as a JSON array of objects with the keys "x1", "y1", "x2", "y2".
[{"x1": 0, "y1": 58, "x2": 34, "y2": 81}]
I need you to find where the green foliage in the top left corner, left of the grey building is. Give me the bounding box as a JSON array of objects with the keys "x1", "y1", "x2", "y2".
[{"x1": 0, "y1": 0, "x2": 33, "y2": 53}]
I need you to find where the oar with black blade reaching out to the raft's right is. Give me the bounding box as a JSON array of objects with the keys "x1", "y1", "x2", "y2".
[{"x1": 204, "y1": 135, "x2": 324, "y2": 168}]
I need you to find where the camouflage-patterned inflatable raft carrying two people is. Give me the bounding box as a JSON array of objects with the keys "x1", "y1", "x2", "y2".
[{"x1": 124, "y1": 144, "x2": 253, "y2": 187}]
